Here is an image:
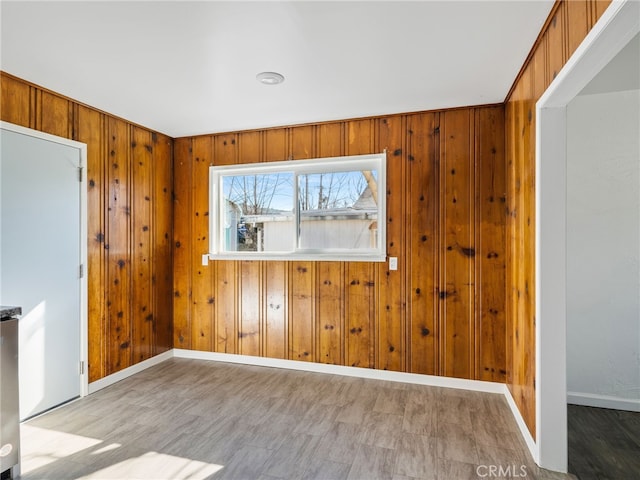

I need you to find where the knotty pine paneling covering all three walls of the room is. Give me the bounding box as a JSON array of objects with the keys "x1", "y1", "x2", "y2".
[{"x1": 0, "y1": 0, "x2": 609, "y2": 404}]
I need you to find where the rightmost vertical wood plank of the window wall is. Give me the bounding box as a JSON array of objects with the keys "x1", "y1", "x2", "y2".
[{"x1": 475, "y1": 107, "x2": 507, "y2": 382}]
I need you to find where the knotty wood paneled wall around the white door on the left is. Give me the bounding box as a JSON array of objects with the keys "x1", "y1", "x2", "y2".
[{"x1": 0, "y1": 73, "x2": 173, "y2": 381}]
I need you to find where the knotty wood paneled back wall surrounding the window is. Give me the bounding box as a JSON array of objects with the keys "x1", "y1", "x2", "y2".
[{"x1": 174, "y1": 105, "x2": 506, "y2": 382}]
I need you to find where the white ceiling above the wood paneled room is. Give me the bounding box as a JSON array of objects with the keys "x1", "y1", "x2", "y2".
[{"x1": 0, "y1": 0, "x2": 554, "y2": 137}]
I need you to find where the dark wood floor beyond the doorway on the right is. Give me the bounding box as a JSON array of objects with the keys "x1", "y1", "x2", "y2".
[{"x1": 567, "y1": 405, "x2": 640, "y2": 480}]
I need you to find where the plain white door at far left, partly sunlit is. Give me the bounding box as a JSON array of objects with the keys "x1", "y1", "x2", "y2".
[{"x1": 0, "y1": 127, "x2": 83, "y2": 420}]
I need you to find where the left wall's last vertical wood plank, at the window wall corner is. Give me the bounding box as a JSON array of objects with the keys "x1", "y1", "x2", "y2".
[{"x1": 152, "y1": 133, "x2": 173, "y2": 355}]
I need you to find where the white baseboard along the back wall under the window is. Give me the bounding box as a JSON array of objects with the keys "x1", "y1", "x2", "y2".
[{"x1": 173, "y1": 348, "x2": 504, "y2": 393}]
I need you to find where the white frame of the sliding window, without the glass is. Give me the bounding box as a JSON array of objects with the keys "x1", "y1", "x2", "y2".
[{"x1": 208, "y1": 151, "x2": 387, "y2": 262}]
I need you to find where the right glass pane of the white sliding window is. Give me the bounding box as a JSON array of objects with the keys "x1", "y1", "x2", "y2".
[{"x1": 298, "y1": 170, "x2": 378, "y2": 249}]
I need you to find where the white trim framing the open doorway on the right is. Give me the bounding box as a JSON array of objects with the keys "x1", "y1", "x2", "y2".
[{"x1": 536, "y1": 0, "x2": 640, "y2": 472}]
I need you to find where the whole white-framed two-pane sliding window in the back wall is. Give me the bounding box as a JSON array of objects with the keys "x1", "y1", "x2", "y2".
[{"x1": 209, "y1": 153, "x2": 386, "y2": 261}]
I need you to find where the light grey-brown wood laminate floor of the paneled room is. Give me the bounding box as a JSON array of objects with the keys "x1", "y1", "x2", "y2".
[{"x1": 22, "y1": 359, "x2": 574, "y2": 480}]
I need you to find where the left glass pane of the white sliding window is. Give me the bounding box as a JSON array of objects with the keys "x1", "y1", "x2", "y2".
[{"x1": 221, "y1": 172, "x2": 295, "y2": 252}]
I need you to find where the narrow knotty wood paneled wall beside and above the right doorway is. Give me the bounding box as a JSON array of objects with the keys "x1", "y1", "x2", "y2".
[{"x1": 506, "y1": 0, "x2": 610, "y2": 438}]
